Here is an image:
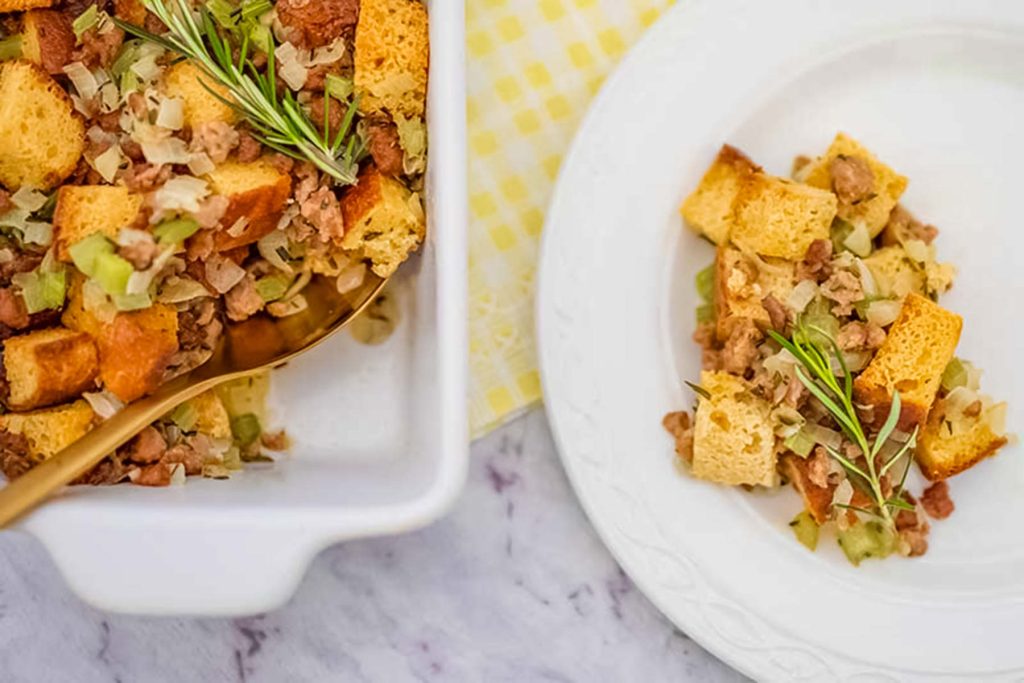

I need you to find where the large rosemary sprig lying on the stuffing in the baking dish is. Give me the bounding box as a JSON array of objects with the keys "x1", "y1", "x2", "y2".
[{"x1": 114, "y1": 0, "x2": 364, "y2": 184}]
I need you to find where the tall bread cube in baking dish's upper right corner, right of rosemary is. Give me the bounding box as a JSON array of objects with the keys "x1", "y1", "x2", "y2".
[{"x1": 354, "y1": 0, "x2": 430, "y2": 119}]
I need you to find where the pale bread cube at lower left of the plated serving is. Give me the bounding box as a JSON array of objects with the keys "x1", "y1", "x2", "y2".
[{"x1": 692, "y1": 371, "x2": 777, "y2": 486}]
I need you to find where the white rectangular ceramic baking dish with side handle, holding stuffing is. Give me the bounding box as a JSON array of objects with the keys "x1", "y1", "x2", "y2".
[{"x1": 11, "y1": 0, "x2": 467, "y2": 614}]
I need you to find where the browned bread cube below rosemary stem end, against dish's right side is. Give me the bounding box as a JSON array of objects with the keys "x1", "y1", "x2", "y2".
[{"x1": 341, "y1": 166, "x2": 427, "y2": 278}]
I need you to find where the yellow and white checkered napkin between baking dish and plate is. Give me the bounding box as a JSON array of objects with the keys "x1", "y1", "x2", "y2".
[{"x1": 466, "y1": 0, "x2": 672, "y2": 436}]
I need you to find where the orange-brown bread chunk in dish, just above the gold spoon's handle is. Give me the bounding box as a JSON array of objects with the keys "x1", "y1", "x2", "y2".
[{"x1": 61, "y1": 282, "x2": 178, "y2": 403}]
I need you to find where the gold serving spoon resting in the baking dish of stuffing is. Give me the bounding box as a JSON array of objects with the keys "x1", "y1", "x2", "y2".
[{"x1": 0, "y1": 274, "x2": 387, "y2": 528}]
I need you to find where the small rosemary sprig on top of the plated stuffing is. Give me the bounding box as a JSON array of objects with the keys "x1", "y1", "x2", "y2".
[{"x1": 768, "y1": 324, "x2": 918, "y2": 531}]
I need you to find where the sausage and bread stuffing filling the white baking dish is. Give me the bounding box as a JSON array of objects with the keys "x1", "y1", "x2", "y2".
[{"x1": 0, "y1": 0, "x2": 429, "y2": 485}]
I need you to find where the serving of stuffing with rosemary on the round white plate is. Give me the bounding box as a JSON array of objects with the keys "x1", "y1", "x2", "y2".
[{"x1": 664, "y1": 133, "x2": 1009, "y2": 564}]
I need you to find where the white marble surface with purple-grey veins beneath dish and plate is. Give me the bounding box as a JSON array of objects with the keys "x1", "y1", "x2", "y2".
[{"x1": 0, "y1": 412, "x2": 740, "y2": 683}]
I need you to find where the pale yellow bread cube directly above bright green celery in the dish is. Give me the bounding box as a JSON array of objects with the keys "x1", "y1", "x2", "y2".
[{"x1": 53, "y1": 185, "x2": 142, "y2": 263}]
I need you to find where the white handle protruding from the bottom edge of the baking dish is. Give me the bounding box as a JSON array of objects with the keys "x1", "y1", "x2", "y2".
[{"x1": 24, "y1": 520, "x2": 326, "y2": 616}]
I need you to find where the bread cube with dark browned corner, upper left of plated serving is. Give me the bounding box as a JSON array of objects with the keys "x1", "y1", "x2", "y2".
[{"x1": 679, "y1": 144, "x2": 761, "y2": 245}]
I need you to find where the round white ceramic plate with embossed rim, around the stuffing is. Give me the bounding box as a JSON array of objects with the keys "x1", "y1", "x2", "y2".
[{"x1": 538, "y1": 0, "x2": 1024, "y2": 681}]
